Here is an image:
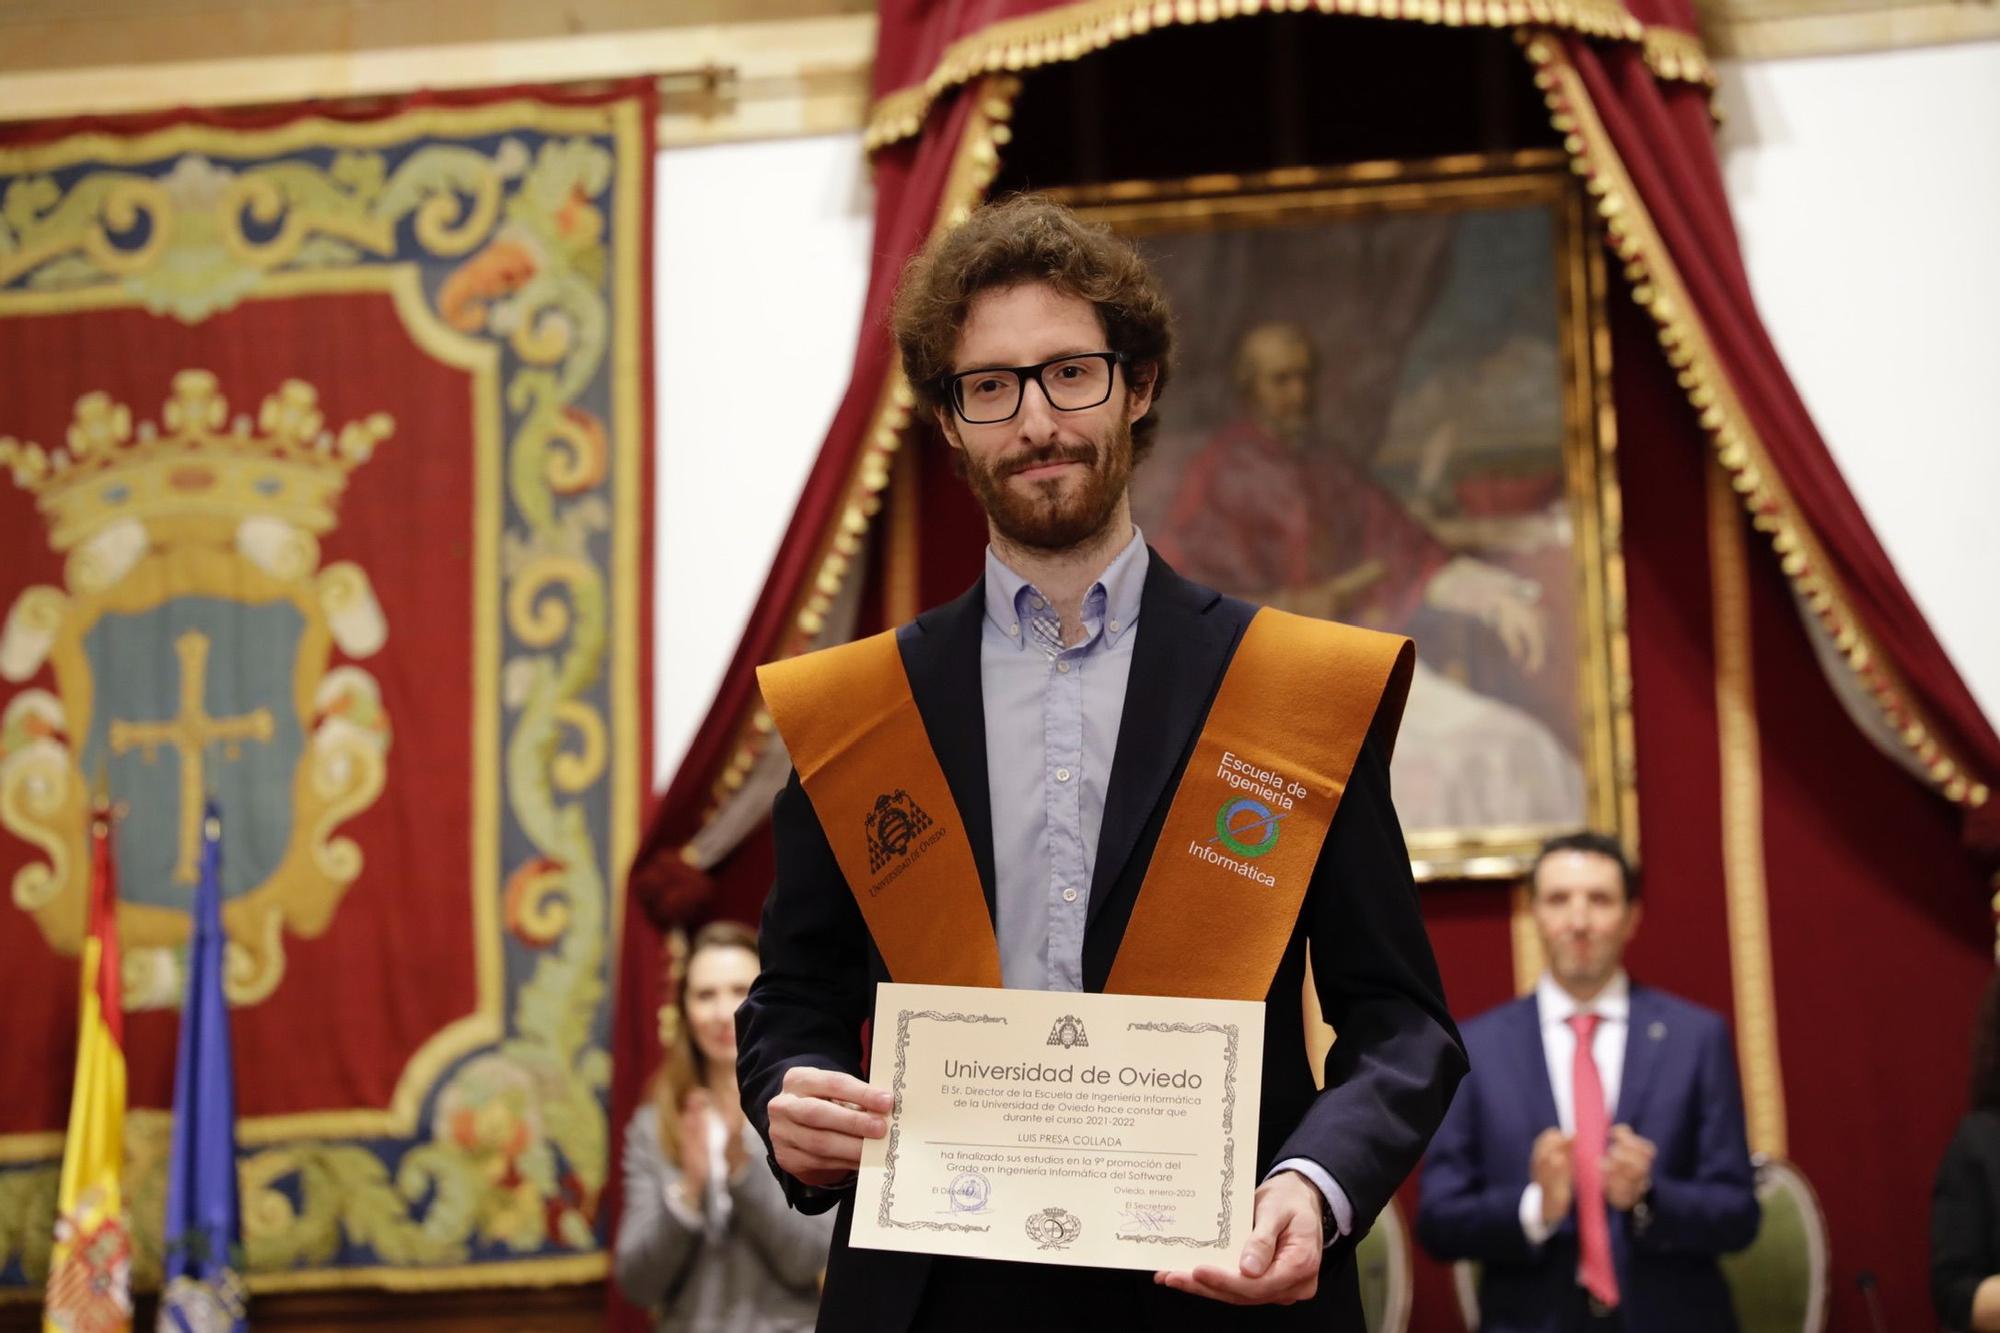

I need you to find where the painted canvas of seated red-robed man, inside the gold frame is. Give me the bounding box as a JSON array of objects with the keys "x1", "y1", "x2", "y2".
[{"x1": 1134, "y1": 192, "x2": 1586, "y2": 845}]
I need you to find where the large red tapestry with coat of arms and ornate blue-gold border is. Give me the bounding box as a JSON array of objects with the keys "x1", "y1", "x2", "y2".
[{"x1": 0, "y1": 88, "x2": 652, "y2": 1295}]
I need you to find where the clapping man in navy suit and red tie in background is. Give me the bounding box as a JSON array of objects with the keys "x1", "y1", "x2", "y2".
[{"x1": 1416, "y1": 833, "x2": 1758, "y2": 1333}]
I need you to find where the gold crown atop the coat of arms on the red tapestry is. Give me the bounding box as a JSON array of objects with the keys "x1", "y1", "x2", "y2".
[{"x1": 0, "y1": 370, "x2": 396, "y2": 552}]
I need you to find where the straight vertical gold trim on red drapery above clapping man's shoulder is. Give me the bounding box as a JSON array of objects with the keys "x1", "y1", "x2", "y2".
[{"x1": 1706, "y1": 456, "x2": 1786, "y2": 1157}]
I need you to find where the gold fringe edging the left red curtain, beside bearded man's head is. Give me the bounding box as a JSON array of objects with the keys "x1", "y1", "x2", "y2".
[{"x1": 682, "y1": 74, "x2": 1020, "y2": 820}]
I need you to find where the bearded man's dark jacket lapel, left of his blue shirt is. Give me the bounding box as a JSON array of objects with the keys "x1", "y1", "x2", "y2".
[{"x1": 896, "y1": 582, "x2": 994, "y2": 919}]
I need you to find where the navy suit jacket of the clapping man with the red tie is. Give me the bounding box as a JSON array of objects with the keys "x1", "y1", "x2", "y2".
[{"x1": 1416, "y1": 985, "x2": 1758, "y2": 1333}]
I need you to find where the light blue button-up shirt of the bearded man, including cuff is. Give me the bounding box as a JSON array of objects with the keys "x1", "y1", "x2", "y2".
[{"x1": 980, "y1": 528, "x2": 1354, "y2": 1241}]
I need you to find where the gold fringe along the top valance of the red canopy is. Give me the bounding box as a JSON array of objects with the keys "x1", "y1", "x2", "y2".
[{"x1": 864, "y1": 0, "x2": 1716, "y2": 152}]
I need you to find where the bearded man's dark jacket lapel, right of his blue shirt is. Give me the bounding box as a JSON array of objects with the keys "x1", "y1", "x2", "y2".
[{"x1": 1084, "y1": 552, "x2": 1242, "y2": 931}]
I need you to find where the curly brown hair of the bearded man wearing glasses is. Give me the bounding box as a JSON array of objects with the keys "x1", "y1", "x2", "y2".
[{"x1": 890, "y1": 194, "x2": 1174, "y2": 462}]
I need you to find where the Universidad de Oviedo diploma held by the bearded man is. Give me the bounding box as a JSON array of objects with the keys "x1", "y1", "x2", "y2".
[{"x1": 850, "y1": 983, "x2": 1264, "y2": 1269}]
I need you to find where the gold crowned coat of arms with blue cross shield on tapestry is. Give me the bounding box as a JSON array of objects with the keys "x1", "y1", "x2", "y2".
[{"x1": 0, "y1": 370, "x2": 394, "y2": 1009}]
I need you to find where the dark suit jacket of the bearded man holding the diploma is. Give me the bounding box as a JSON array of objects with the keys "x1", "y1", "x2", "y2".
[{"x1": 736, "y1": 554, "x2": 1464, "y2": 1333}]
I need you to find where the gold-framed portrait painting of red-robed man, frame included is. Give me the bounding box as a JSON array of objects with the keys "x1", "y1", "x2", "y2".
[{"x1": 1060, "y1": 152, "x2": 1638, "y2": 879}]
